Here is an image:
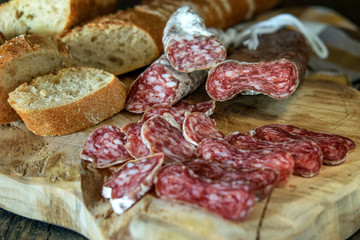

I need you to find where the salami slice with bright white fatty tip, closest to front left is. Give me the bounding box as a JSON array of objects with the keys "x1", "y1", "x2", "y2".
[{"x1": 102, "y1": 153, "x2": 164, "y2": 214}]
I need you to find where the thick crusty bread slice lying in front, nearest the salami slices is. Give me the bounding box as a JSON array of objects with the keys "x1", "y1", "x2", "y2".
[{"x1": 8, "y1": 67, "x2": 126, "y2": 136}]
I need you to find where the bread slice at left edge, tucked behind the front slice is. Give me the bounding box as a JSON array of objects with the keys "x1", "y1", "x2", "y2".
[{"x1": 0, "y1": 35, "x2": 72, "y2": 124}]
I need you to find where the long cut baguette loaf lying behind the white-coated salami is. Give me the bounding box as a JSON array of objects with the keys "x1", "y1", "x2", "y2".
[{"x1": 61, "y1": 0, "x2": 279, "y2": 75}]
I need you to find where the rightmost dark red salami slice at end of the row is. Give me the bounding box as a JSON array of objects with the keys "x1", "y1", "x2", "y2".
[{"x1": 252, "y1": 124, "x2": 349, "y2": 165}]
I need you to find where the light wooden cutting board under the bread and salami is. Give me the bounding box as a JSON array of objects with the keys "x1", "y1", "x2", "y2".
[{"x1": 0, "y1": 75, "x2": 360, "y2": 240}]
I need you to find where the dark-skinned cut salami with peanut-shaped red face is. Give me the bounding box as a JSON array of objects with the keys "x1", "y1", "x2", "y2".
[{"x1": 205, "y1": 28, "x2": 309, "y2": 101}]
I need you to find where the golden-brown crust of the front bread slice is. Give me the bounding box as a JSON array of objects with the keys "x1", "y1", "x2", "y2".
[{"x1": 8, "y1": 67, "x2": 126, "y2": 136}]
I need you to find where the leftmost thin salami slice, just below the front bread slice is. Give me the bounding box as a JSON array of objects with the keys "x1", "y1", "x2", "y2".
[{"x1": 80, "y1": 126, "x2": 133, "y2": 168}]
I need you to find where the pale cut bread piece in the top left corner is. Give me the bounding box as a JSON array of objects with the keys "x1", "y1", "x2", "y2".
[{"x1": 0, "y1": 0, "x2": 116, "y2": 39}]
